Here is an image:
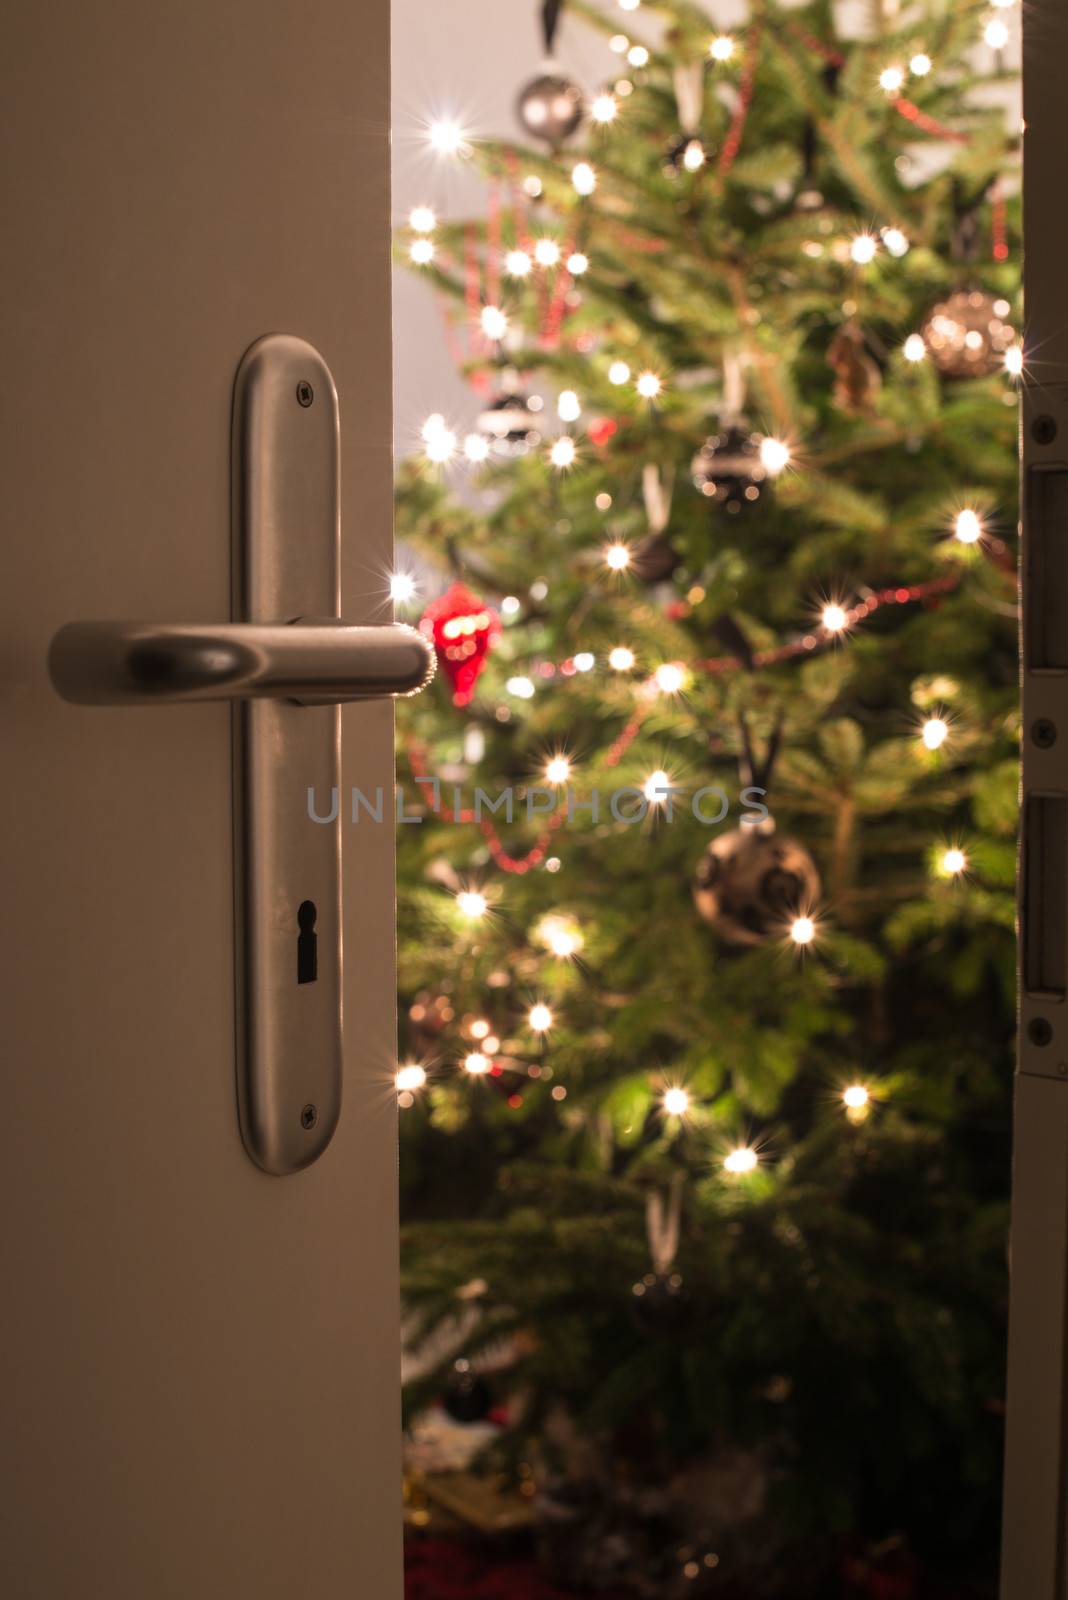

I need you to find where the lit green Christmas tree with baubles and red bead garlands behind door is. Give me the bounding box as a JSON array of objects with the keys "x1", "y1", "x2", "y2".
[{"x1": 393, "y1": 0, "x2": 1023, "y2": 1600}]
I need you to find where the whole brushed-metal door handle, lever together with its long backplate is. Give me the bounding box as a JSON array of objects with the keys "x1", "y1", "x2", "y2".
[{"x1": 48, "y1": 334, "x2": 435, "y2": 1174}]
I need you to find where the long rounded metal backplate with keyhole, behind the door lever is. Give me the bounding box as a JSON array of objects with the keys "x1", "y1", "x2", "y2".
[{"x1": 232, "y1": 334, "x2": 342, "y2": 1174}]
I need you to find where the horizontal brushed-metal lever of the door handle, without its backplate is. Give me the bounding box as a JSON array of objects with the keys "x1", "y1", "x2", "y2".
[{"x1": 48, "y1": 618, "x2": 435, "y2": 706}]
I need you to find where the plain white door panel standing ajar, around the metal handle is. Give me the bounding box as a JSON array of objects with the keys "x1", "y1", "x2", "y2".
[{"x1": 0, "y1": 0, "x2": 401, "y2": 1600}]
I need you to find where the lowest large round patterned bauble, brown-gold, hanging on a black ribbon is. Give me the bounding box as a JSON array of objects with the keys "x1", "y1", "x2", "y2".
[{"x1": 694, "y1": 824, "x2": 820, "y2": 944}]
